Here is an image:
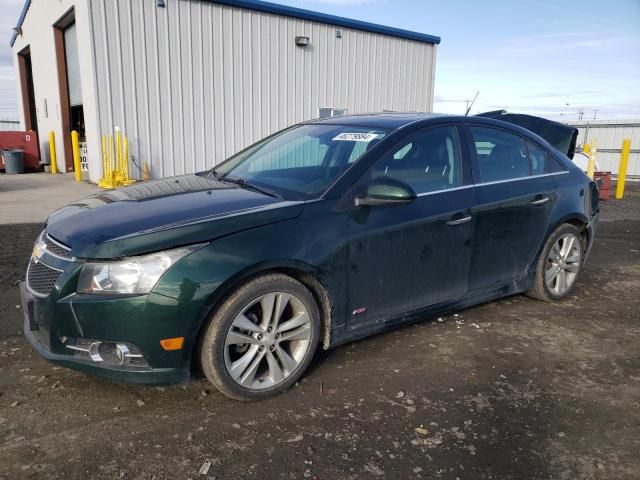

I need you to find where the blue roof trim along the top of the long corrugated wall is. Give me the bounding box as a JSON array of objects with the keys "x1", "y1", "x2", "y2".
[{"x1": 209, "y1": 0, "x2": 440, "y2": 45}]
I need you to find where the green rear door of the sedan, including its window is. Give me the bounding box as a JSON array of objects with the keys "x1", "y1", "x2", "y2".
[{"x1": 467, "y1": 125, "x2": 556, "y2": 291}]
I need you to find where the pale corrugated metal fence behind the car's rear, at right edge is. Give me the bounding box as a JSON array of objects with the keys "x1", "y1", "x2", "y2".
[{"x1": 573, "y1": 120, "x2": 640, "y2": 177}]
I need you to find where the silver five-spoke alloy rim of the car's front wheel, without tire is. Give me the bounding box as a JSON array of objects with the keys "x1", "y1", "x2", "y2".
[{"x1": 224, "y1": 292, "x2": 312, "y2": 390}]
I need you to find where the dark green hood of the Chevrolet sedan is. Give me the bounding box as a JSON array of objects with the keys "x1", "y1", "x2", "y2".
[{"x1": 46, "y1": 175, "x2": 304, "y2": 258}]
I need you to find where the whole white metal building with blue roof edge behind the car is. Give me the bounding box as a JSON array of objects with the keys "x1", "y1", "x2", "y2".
[{"x1": 11, "y1": 0, "x2": 440, "y2": 182}]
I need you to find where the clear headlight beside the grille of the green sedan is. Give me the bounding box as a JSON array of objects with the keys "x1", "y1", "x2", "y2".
[{"x1": 78, "y1": 245, "x2": 202, "y2": 294}]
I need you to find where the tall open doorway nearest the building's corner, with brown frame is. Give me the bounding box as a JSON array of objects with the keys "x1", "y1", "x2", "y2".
[{"x1": 54, "y1": 10, "x2": 85, "y2": 172}]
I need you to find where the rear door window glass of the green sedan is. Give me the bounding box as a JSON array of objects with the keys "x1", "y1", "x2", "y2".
[{"x1": 470, "y1": 127, "x2": 529, "y2": 182}]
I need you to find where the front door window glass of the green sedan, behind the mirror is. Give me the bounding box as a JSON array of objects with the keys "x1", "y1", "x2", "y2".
[{"x1": 372, "y1": 126, "x2": 462, "y2": 194}]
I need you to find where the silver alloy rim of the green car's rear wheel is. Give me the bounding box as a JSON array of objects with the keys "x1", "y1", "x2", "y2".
[{"x1": 545, "y1": 233, "x2": 582, "y2": 295}]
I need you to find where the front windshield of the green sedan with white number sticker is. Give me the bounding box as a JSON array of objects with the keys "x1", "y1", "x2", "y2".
[{"x1": 212, "y1": 124, "x2": 387, "y2": 199}]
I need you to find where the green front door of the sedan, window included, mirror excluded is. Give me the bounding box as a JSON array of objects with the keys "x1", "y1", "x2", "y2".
[{"x1": 348, "y1": 126, "x2": 475, "y2": 327}]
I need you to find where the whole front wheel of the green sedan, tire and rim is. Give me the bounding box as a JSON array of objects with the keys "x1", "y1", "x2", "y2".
[{"x1": 199, "y1": 273, "x2": 320, "y2": 401}]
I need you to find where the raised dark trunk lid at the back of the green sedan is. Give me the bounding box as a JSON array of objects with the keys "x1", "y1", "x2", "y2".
[{"x1": 476, "y1": 110, "x2": 578, "y2": 158}]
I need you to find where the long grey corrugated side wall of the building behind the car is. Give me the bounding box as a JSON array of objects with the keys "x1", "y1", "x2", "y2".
[{"x1": 90, "y1": 0, "x2": 435, "y2": 180}]
